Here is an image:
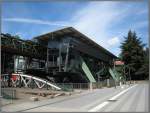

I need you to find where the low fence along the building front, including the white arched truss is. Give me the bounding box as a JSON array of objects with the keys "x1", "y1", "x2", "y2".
[{"x1": 1, "y1": 74, "x2": 123, "y2": 91}]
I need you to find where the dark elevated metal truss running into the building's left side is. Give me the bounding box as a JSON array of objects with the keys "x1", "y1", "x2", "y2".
[{"x1": 1, "y1": 34, "x2": 47, "y2": 59}]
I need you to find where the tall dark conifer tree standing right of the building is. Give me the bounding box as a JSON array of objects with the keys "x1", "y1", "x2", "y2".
[{"x1": 121, "y1": 30, "x2": 145, "y2": 79}]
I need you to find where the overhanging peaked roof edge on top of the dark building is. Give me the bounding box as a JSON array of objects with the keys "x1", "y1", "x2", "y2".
[{"x1": 34, "y1": 27, "x2": 117, "y2": 58}]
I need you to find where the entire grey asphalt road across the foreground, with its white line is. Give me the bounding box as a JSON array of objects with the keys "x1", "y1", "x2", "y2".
[{"x1": 2, "y1": 83, "x2": 149, "y2": 112}]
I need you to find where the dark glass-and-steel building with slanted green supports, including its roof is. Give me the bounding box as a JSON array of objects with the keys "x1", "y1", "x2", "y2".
[{"x1": 34, "y1": 27, "x2": 117, "y2": 82}]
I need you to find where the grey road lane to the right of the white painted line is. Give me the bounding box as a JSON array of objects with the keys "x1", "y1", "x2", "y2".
[{"x1": 96, "y1": 84, "x2": 149, "y2": 112}]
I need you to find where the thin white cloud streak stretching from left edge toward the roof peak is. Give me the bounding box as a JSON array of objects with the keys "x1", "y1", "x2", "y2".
[{"x1": 2, "y1": 18, "x2": 69, "y2": 27}]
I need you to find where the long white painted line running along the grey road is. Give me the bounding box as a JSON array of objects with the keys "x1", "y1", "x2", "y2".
[{"x1": 88, "y1": 85, "x2": 137, "y2": 112}]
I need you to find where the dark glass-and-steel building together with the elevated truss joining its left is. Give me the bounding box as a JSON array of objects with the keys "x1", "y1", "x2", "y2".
[{"x1": 2, "y1": 27, "x2": 117, "y2": 83}]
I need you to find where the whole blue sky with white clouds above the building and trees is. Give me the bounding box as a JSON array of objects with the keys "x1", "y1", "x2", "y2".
[{"x1": 1, "y1": 0, "x2": 148, "y2": 56}]
